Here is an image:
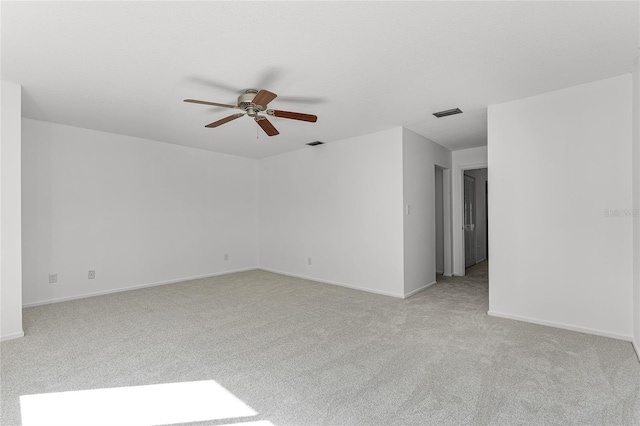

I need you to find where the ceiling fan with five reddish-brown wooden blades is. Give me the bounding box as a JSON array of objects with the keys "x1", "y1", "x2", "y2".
[{"x1": 184, "y1": 89, "x2": 318, "y2": 136}]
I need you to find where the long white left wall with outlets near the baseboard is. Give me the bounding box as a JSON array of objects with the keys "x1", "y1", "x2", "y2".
[{"x1": 22, "y1": 119, "x2": 258, "y2": 305}]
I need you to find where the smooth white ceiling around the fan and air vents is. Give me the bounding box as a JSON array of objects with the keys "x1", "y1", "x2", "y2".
[{"x1": 1, "y1": 1, "x2": 640, "y2": 158}]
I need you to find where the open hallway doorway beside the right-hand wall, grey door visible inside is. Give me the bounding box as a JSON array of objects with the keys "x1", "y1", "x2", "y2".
[{"x1": 463, "y1": 167, "x2": 489, "y2": 269}]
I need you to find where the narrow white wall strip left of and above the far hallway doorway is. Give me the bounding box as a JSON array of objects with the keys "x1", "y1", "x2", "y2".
[{"x1": 451, "y1": 146, "x2": 491, "y2": 276}]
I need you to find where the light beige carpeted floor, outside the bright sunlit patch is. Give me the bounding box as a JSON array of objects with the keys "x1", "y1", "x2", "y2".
[{"x1": 0, "y1": 264, "x2": 640, "y2": 426}]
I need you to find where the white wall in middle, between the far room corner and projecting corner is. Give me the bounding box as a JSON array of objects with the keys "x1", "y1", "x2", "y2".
[{"x1": 258, "y1": 127, "x2": 404, "y2": 297}]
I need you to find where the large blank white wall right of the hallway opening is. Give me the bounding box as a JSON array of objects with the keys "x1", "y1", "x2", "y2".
[{"x1": 488, "y1": 74, "x2": 633, "y2": 340}]
